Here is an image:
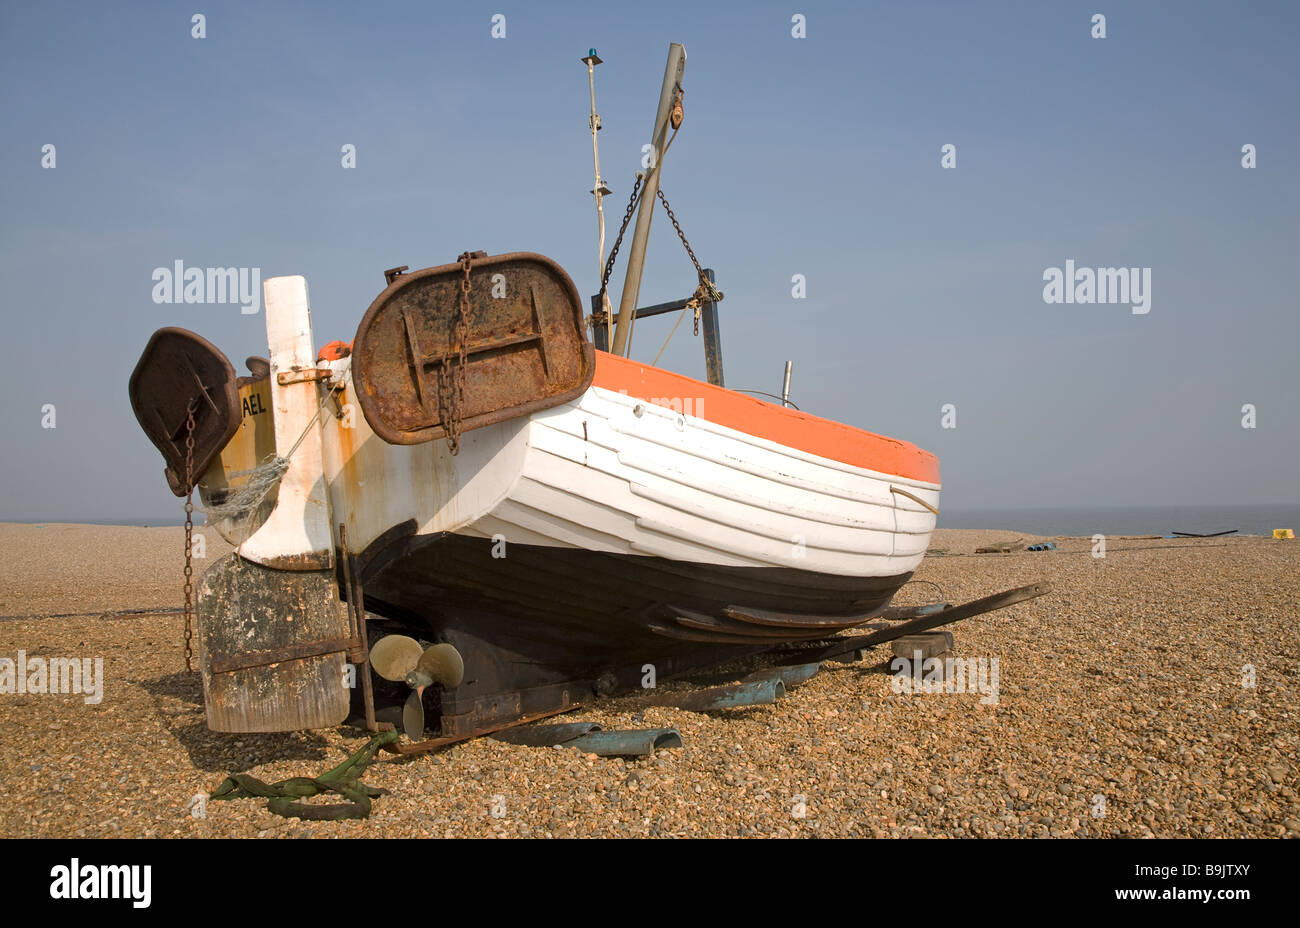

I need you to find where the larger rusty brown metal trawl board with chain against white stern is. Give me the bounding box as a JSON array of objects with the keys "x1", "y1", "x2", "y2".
[{"x1": 352, "y1": 252, "x2": 595, "y2": 445}]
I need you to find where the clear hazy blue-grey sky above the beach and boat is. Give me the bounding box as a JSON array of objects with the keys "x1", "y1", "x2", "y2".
[{"x1": 0, "y1": 0, "x2": 1300, "y2": 522}]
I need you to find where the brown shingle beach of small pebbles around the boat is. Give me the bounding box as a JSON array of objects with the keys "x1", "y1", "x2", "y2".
[{"x1": 0, "y1": 525, "x2": 1300, "y2": 837}]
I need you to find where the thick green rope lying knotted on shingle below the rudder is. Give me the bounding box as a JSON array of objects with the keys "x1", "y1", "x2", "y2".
[{"x1": 211, "y1": 732, "x2": 399, "y2": 821}]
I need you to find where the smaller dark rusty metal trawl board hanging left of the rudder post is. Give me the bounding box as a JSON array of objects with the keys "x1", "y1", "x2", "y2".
[{"x1": 130, "y1": 326, "x2": 242, "y2": 496}]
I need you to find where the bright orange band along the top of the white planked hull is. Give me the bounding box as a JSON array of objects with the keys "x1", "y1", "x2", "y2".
[{"x1": 592, "y1": 351, "x2": 939, "y2": 483}]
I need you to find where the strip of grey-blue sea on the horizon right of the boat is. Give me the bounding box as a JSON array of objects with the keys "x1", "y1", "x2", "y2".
[{"x1": 939, "y1": 503, "x2": 1300, "y2": 535}]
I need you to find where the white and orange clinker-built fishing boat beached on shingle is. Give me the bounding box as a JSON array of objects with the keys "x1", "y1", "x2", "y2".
[{"x1": 130, "y1": 45, "x2": 940, "y2": 741}]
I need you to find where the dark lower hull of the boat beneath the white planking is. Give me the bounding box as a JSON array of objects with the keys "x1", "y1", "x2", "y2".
[{"x1": 359, "y1": 534, "x2": 911, "y2": 736}]
